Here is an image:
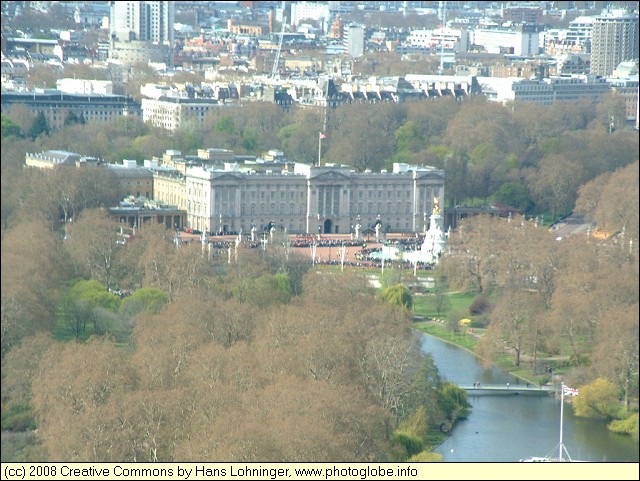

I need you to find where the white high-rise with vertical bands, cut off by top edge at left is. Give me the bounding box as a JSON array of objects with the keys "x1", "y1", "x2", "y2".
[{"x1": 109, "y1": 1, "x2": 175, "y2": 64}]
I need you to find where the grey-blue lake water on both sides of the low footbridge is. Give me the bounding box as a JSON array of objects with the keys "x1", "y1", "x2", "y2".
[{"x1": 422, "y1": 334, "x2": 639, "y2": 462}]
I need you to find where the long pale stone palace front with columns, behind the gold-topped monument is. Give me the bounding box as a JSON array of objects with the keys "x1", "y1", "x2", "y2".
[{"x1": 185, "y1": 163, "x2": 444, "y2": 234}]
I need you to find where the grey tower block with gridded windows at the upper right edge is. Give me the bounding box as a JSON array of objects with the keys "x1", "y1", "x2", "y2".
[{"x1": 591, "y1": 10, "x2": 640, "y2": 77}]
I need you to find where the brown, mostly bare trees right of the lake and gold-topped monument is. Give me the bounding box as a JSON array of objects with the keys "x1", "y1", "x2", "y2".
[{"x1": 441, "y1": 161, "x2": 639, "y2": 407}]
